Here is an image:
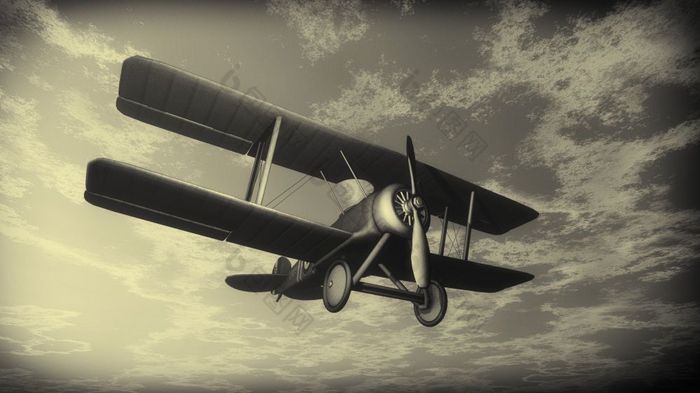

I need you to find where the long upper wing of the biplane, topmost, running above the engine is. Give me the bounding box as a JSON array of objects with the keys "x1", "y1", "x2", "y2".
[{"x1": 117, "y1": 56, "x2": 538, "y2": 234}]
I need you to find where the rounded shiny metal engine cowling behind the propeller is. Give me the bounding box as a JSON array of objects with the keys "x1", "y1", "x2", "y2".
[{"x1": 372, "y1": 184, "x2": 430, "y2": 237}]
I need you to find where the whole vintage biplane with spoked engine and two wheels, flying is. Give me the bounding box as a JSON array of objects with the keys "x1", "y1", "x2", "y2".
[{"x1": 85, "y1": 56, "x2": 538, "y2": 326}]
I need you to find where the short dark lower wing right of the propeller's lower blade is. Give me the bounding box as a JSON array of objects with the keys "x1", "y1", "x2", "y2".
[{"x1": 430, "y1": 254, "x2": 535, "y2": 292}]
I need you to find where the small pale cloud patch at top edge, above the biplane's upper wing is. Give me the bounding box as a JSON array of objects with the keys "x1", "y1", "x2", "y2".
[{"x1": 267, "y1": 0, "x2": 369, "y2": 64}]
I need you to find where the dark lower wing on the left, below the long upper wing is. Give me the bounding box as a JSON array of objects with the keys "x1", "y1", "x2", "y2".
[{"x1": 85, "y1": 158, "x2": 351, "y2": 261}]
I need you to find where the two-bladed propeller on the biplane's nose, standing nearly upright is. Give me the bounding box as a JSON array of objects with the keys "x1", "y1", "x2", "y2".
[{"x1": 406, "y1": 136, "x2": 430, "y2": 289}]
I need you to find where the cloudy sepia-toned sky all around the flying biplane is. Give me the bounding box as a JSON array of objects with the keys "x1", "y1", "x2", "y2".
[{"x1": 0, "y1": 0, "x2": 700, "y2": 392}]
